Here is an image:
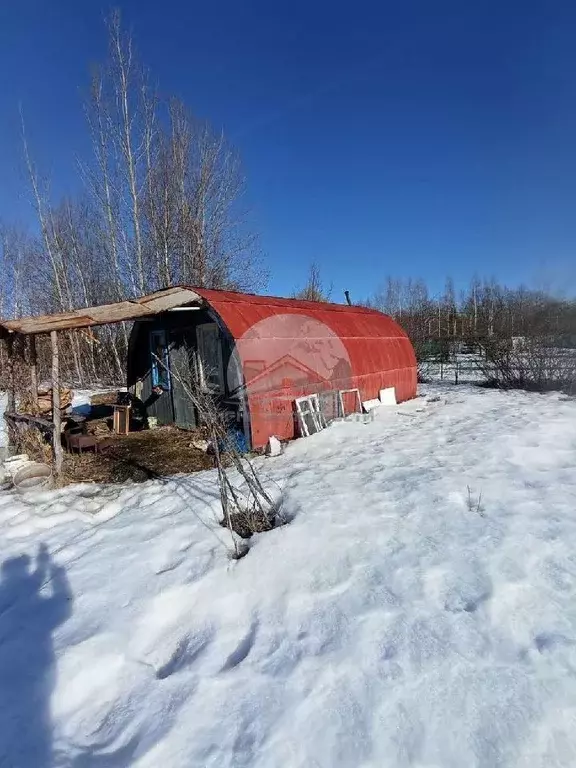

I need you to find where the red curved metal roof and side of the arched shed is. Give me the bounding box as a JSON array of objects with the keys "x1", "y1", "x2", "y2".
[{"x1": 192, "y1": 288, "x2": 417, "y2": 447}]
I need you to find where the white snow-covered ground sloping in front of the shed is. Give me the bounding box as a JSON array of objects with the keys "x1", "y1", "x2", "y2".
[{"x1": 0, "y1": 386, "x2": 576, "y2": 768}]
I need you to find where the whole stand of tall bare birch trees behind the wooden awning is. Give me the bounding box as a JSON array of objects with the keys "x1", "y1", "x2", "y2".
[{"x1": 0, "y1": 7, "x2": 266, "y2": 382}]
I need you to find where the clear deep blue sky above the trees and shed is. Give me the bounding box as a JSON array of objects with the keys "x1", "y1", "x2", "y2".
[{"x1": 0, "y1": 0, "x2": 576, "y2": 300}]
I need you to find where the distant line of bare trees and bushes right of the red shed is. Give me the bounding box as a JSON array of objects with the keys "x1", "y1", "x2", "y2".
[{"x1": 365, "y1": 277, "x2": 576, "y2": 392}]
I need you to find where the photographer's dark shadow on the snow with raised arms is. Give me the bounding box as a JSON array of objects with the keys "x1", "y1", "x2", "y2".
[{"x1": 0, "y1": 545, "x2": 72, "y2": 768}]
